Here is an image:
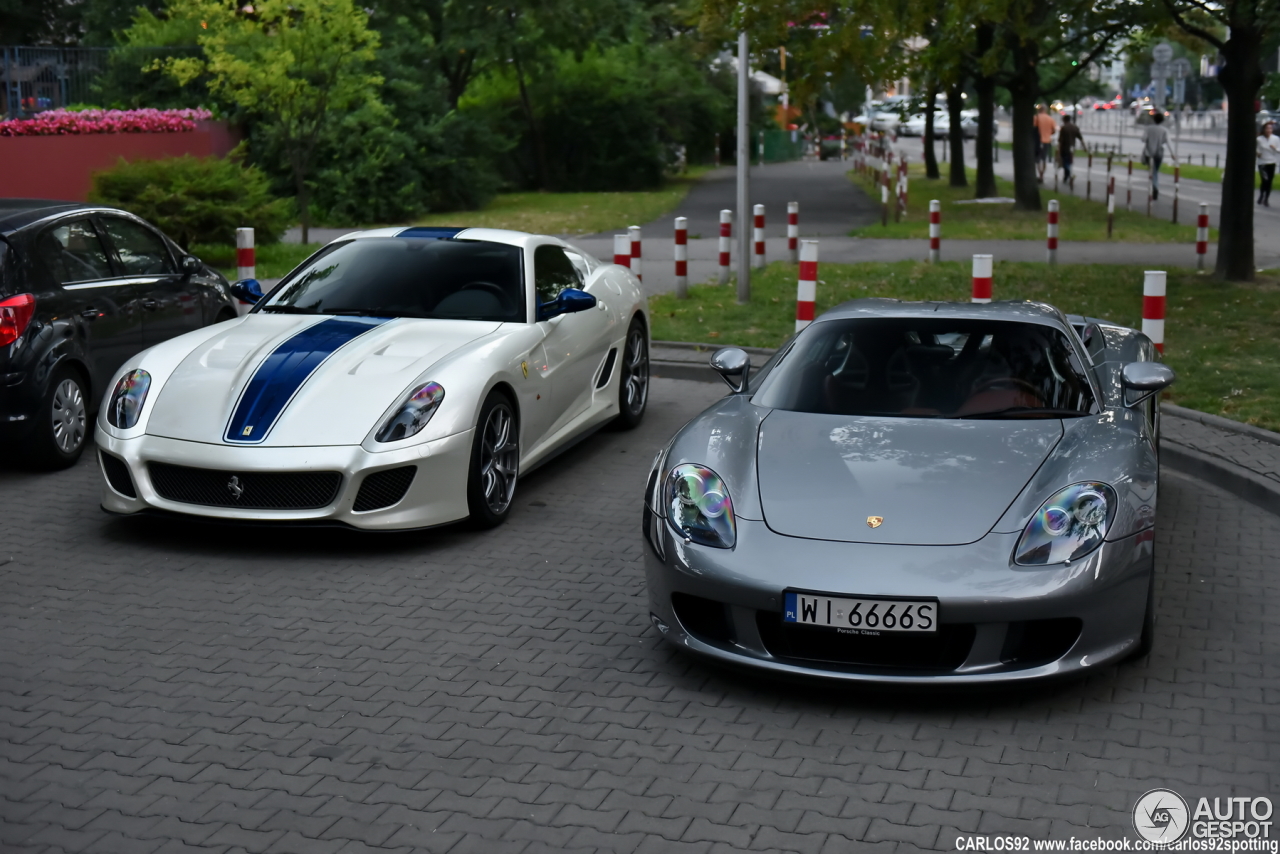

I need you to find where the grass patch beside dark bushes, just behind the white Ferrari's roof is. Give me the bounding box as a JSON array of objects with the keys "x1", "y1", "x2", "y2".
[{"x1": 416, "y1": 166, "x2": 710, "y2": 234}]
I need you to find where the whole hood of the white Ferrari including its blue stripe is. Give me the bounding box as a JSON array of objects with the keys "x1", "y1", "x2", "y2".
[{"x1": 146, "y1": 314, "x2": 500, "y2": 447}]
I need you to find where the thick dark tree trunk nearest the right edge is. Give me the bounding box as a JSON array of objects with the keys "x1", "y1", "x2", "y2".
[{"x1": 1164, "y1": 0, "x2": 1280, "y2": 282}]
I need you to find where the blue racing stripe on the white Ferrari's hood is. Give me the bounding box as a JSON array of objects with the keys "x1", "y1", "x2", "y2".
[{"x1": 227, "y1": 318, "x2": 389, "y2": 444}]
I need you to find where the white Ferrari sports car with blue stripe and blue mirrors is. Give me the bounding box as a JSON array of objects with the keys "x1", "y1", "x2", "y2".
[{"x1": 97, "y1": 228, "x2": 649, "y2": 530}]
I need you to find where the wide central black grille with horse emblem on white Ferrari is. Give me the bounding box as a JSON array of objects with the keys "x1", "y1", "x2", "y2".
[{"x1": 147, "y1": 462, "x2": 342, "y2": 510}]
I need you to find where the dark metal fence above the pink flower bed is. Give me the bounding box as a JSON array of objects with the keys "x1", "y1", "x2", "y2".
[{"x1": 0, "y1": 46, "x2": 111, "y2": 118}]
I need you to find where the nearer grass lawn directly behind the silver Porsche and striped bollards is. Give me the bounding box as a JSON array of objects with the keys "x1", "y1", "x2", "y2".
[{"x1": 649, "y1": 261, "x2": 1280, "y2": 430}]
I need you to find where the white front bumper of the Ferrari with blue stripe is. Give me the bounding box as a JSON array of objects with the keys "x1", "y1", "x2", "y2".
[{"x1": 97, "y1": 429, "x2": 474, "y2": 530}]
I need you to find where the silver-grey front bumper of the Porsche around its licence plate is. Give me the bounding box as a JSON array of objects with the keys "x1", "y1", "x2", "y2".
[{"x1": 644, "y1": 510, "x2": 1155, "y2": 685}]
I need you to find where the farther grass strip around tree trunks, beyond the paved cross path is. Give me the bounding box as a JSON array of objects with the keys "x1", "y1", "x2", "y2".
[{"x1": 850, "y1": 163, "x2": 1217, "y2": 243}]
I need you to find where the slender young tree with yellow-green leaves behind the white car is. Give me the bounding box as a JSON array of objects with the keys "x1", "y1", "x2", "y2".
[{"x1": 160, "y1": 0, "x2": 383, "y2": 242}]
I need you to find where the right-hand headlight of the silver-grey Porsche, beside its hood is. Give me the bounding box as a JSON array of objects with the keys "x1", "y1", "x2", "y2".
[{"x1": 1014, "y1": 483, "x2": 1116, "y2": 566}]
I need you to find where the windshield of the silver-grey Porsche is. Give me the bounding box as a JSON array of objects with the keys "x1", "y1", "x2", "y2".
[{"x1": 753, "y1": 318, "x2": 1094, "y2": 419}]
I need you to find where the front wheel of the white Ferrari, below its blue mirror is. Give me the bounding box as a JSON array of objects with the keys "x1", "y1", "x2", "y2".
[{"x1": 467, "y1": 391, "x2": 520, "y2": 528}]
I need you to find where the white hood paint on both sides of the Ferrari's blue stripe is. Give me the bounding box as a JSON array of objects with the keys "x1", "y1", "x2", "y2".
[{"x1": 146, "y1": 312, "x2": 502, "y2": 447}]
